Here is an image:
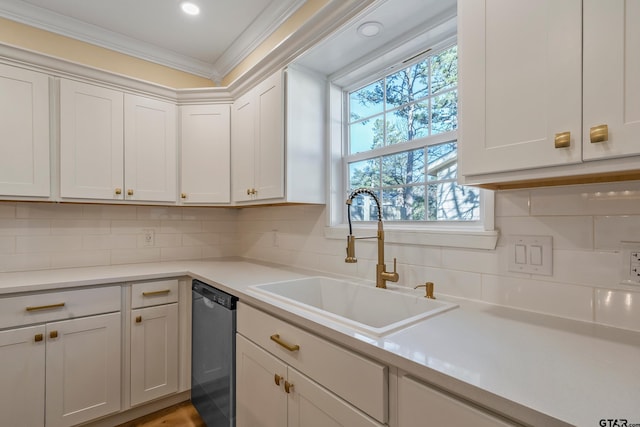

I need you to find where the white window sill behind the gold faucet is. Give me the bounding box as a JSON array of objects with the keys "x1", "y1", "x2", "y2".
[{"x1": 324, "y1": 225, "x2": 499, "y2": 250}]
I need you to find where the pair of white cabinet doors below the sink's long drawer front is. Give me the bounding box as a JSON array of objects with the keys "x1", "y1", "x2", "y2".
[{"x1": 236, "y1": 335, "x2": 382, "y2": 427}]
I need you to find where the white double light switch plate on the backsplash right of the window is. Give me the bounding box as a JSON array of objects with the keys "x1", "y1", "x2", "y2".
[{"x1": 507, "y1": 235, "x2": 553, "y2": 276}]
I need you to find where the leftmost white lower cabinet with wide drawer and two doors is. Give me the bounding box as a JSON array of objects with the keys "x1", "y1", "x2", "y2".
[{"x1": 0, "y1": 286, "x2": 122, "y2": 427}]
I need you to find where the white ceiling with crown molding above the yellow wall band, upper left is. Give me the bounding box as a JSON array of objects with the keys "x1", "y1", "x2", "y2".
[{"x1": 0, "y1": 0, "x2": 304, "y2": 82}]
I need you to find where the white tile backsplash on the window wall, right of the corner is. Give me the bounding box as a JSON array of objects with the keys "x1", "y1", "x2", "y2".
[{"x1": 238, "y1": 182, "x2": 640, "y2": 330}]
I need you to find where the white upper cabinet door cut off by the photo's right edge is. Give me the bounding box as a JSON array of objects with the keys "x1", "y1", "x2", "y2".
[{"x1": 582, "y1": 0, "x2": 640, "y2": 160}]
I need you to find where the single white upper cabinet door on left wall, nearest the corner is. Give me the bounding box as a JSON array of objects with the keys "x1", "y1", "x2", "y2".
[{"x1": 181, "y1": 105, "x2": 231, "y2": 204}]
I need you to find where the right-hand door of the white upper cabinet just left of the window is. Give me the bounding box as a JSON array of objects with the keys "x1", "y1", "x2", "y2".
[{"x1": 255, "y1": 71, "x2": 284, "y2": 200}]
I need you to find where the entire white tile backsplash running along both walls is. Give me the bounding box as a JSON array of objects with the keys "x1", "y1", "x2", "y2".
[{"x1": 0, "y1": 181, "x2": 640, "y2": 331}]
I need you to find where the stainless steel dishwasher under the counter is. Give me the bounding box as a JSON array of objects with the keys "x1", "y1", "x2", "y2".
[{"x1": 191, "y1": 280, "x2": 238, "y2": 427}]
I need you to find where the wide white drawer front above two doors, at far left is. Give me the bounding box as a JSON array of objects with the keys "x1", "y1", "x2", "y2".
[{"x1": 0, "y1": 285, "x2": 120, "y2": 328}]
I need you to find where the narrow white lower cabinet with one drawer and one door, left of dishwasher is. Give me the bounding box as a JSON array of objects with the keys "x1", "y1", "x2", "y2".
[{"x1": 130, "y1": 279, "x2": 179, "y2": 406}]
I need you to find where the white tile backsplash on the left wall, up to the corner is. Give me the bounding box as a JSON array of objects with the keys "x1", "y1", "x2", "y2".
[{"x1": 0, "y1": 202, "x2": 238, "y2": 272}]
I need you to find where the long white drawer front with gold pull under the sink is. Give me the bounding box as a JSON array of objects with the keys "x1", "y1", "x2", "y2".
[{"x1": 237, "y1": 303, "x2": 389, "y2": 423}]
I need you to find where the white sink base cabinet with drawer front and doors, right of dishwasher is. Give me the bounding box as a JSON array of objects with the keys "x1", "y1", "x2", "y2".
[{"x1": 236, "y1": 303, "x2": 388, "y2": 427}]
